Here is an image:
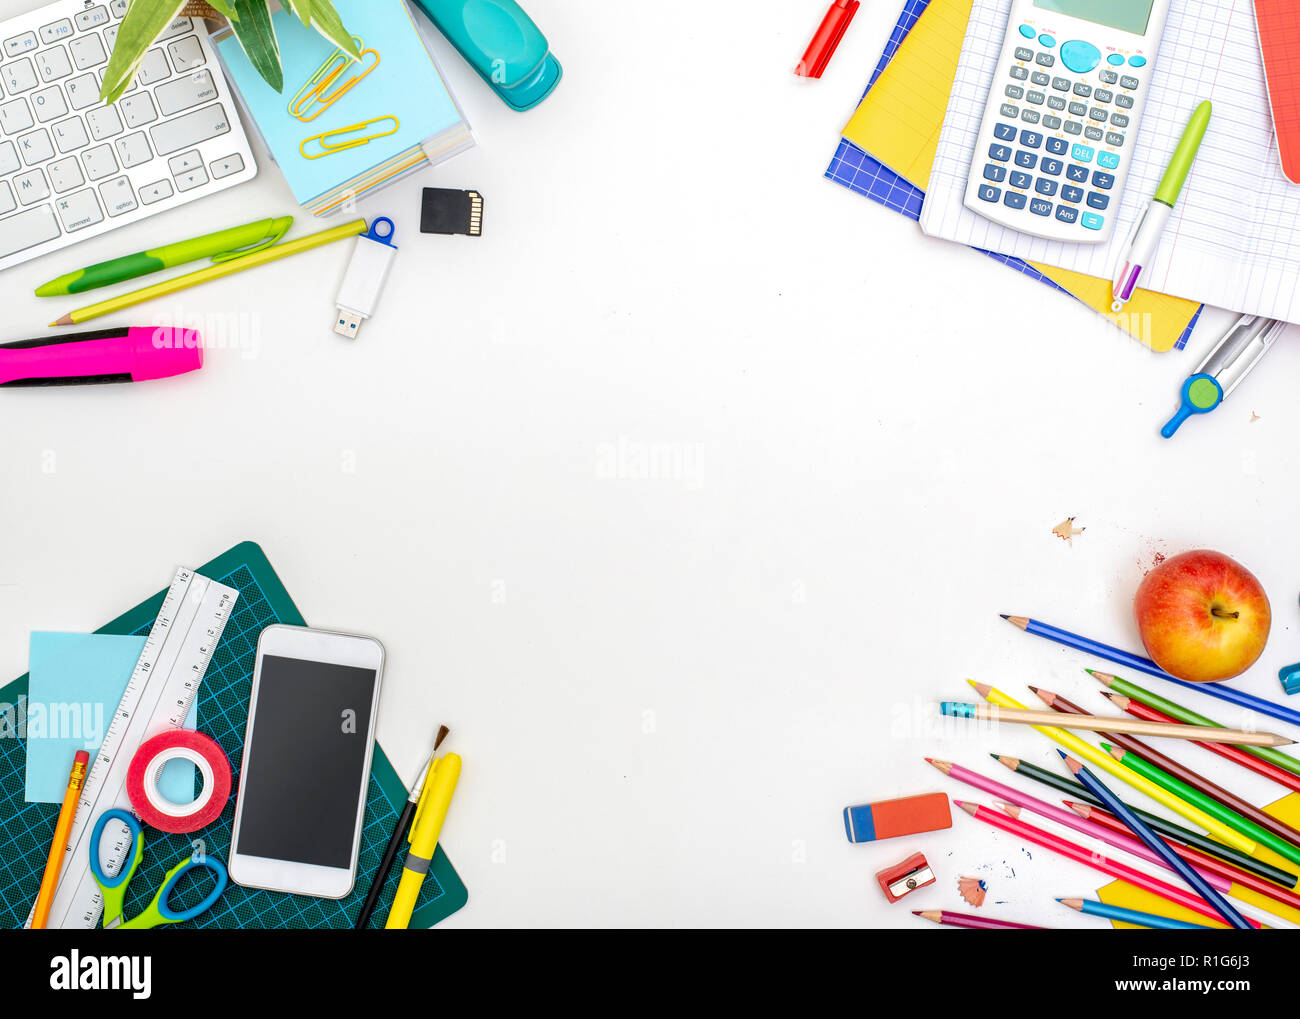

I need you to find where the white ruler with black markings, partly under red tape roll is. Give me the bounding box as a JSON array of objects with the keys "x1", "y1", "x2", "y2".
[{"x1": 27, "y1": 567, "x2": 239, "y2": 928}]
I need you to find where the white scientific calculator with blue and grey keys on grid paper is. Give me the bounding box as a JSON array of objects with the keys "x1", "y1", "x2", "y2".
[{"x1": 966, "y1": 0, "x2": 1169, "y2": 244}]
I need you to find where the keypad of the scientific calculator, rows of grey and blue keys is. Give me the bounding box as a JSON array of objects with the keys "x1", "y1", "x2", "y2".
[{"x1": 975, "y1": 30, "x2": 1145, "y2": 235}]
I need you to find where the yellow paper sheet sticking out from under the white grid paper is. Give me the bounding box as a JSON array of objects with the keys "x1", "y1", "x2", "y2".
[{"x1": 844, "y1": 0, "x2": 1200, "y2": 351}]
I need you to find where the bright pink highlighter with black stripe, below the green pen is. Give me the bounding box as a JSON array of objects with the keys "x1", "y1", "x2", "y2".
[{"x1": 0, "y1": 326, "x2": 203, "y2": 386}]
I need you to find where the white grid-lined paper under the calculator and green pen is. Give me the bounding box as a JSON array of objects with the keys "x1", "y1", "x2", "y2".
[{"x1": 920, "y1": 0, "x2": 1300, "y2": 321}]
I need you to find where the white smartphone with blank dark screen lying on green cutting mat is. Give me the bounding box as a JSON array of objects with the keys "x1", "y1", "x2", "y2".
[{"x1": 229, "y1": 625, "x2": 384, "y2": 898}]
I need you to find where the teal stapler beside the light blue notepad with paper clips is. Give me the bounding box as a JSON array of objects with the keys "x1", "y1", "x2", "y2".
[{"x1": 415, "y1": 0, "x2": 564, "y2": 110}]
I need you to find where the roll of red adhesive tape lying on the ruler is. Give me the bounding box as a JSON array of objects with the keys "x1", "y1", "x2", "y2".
[{"x1": 126, "y1": 729, "x2": 230, "y2": 834}]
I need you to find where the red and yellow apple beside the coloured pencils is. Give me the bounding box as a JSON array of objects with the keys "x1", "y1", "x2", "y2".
[{"x1": 1134, "y1": 550, "x2": 1273, "y2": 682}]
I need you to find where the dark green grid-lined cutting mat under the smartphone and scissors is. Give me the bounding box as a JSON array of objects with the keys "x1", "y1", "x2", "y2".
[{"x1": 0, "y1": 542, "x2": 468, "y2": 928}]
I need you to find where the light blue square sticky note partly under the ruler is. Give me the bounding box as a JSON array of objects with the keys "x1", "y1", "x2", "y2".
[{"x1": 25, "y1": 633, "x2": 199, "y2": 803}]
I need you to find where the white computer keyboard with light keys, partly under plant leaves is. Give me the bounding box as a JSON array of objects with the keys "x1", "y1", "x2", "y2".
[{"x1": 0, "y1": 0, "x2": 257, "y2": 269}]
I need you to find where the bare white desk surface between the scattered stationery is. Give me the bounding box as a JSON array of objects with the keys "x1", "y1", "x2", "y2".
[{"x1": 0, "y1": 0, "x2": 1300, "y2": 927}]
